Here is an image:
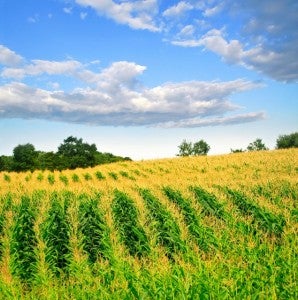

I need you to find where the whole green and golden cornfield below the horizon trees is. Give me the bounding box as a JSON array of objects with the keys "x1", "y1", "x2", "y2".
[{"x1": 0, "y1": 149, "x2": 298, "y2": 299}]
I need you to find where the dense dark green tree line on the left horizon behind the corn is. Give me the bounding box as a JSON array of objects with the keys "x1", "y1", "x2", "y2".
[{"x1": 0, "y1": 136, "x2": 131, "y2": 172}]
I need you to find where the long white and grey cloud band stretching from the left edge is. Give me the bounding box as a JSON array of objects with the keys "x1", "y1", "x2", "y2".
[{"x1": 0, "y1": 49, "x2": 261, "y2": 127}]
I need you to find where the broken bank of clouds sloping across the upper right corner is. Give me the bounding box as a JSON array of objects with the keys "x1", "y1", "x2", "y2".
[{"x1": 69, "y1": 0, "x2": 298, "y2": 82}]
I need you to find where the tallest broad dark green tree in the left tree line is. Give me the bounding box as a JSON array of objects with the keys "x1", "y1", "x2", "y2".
[{"x1": 57, "y1": 136, "x2": 97, "y2": 169}]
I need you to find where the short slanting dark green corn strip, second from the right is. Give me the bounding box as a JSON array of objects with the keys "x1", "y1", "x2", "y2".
[{"x1": 191, "y1": 186, "x2": 228, "y2": 220}]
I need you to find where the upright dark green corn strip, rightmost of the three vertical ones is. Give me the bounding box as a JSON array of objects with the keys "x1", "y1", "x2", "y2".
[{"x1": 78, "y1": 197, "x2": 111, "y2": 263}]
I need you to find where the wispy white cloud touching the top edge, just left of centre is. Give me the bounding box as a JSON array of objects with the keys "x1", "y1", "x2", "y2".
[{"x1": 75, "y1": 0, "x2": 159, "y2": 31}]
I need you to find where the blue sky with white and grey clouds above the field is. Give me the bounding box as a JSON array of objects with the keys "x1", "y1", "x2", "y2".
[{"x1": 0, "y1": 0, "x2": 298, "y2": 160}]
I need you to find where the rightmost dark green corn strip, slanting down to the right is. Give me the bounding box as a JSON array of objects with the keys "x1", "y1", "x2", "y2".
[{"x1": 225, "y1": 188, "x2": 286, "y2": 236}]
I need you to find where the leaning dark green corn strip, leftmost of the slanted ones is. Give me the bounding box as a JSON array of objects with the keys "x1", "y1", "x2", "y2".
[{"x1": 112, "y1": 190, "x2": 150, "y2": 257}]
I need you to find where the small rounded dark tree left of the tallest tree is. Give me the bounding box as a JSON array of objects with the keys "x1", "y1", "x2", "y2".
[{"x1": 13, "y1": 143, "x2": 38, "y2": 171}]
